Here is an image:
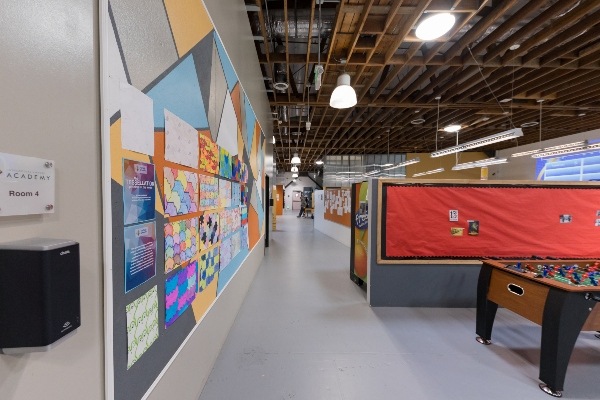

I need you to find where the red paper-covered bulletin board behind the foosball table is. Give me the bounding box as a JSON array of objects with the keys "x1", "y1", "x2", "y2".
[{"x1": 380, "y1": 183, "x2": 600, "y2": 260}]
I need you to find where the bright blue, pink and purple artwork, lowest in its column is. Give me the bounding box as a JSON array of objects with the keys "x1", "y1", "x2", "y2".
[{"x1": 165, "y1": 261, "x2": 198, "y2": 328}]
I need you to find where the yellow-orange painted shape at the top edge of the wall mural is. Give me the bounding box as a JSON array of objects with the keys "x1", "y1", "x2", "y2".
[{"x1": 164, "y1": 0, "x2": 213, "y2": 57}]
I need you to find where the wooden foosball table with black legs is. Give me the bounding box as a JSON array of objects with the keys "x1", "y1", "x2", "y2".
[{"x1": 476, "y1": 260, "x2": 600, "y2": 397}]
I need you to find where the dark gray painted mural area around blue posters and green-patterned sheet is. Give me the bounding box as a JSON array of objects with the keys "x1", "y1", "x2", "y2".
[{"x1": 111, "y1": 181, "x2": 196, "y2": 400}]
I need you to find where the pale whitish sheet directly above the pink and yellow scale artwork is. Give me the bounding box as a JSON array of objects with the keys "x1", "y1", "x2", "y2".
[{"x1": 165, "y1": 109, "x2": 198, "y2": 168}]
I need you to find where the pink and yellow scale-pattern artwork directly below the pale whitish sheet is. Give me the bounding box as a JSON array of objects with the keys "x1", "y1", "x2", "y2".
[{"x1": 164, "y1": 167, "x2": 198, "y2": 216}]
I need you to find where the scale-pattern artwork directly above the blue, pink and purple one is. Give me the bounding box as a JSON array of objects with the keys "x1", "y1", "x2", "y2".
[{"x1": 165, "y1": 218, "x2": 198, "y2": 274}]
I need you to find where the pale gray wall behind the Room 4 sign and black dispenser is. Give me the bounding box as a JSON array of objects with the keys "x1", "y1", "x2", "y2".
[{"x1": 0, "y1": 0, "x2": 104, "y2": 400}]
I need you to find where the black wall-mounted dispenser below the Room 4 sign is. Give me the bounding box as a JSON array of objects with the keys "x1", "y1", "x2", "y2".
[{"x1": 0, "y1": 238, "x2": 81, "y2": 354}]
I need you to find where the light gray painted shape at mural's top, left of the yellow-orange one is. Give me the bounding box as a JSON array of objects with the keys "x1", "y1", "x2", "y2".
[{"x1": 110, "y1": 0, "x2": 178, "y2": 90}]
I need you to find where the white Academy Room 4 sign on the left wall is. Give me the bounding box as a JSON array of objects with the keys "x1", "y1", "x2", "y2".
[{"x1": 0, "y1": 153, "x2": 55, "y2": 216}]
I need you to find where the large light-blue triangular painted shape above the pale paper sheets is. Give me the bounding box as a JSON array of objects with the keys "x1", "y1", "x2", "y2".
[{"x1": 146, "y1": 54, "x2": 208, "y2": 129}]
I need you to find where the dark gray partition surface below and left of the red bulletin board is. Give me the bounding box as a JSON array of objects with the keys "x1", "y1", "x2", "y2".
[{"x1": 368, "y1": 179, "x2": 481, "y2": 307}]
